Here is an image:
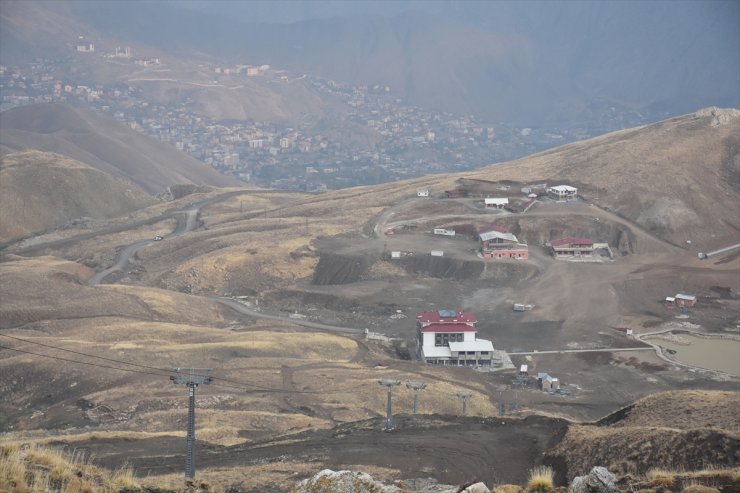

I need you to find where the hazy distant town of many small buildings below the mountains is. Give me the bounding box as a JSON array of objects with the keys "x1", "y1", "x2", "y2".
[{"x1": 0, "y1": 45, "x2": 656, "y2": 191}]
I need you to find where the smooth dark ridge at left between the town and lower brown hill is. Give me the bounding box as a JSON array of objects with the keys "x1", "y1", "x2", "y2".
[{"x1": 0, "y1": 104, "x2": 236, "y2": 194}]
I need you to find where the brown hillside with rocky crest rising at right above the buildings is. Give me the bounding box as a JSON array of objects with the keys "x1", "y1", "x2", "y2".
[{"x1": 466, "y1": 108, "x2": 740, "y2": 247}]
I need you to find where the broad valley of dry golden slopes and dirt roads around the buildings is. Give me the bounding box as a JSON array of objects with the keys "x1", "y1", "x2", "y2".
[{"x1": 0, "y1": 107, "x2": 740, "y2": 491}]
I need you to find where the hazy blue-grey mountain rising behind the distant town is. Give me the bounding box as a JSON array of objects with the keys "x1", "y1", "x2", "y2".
[{"x1": 2, "y1": 1, "x2": 740, "y2": 125}]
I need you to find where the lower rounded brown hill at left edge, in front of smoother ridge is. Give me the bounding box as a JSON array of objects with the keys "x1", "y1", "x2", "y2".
[{"x1": 0, "y1": 151, "x2": 153, "y2": 241}]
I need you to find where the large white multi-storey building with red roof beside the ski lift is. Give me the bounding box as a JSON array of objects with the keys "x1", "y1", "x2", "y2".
[{"x1": 416, "y1": 310, "x2": 493, "y2": 366}]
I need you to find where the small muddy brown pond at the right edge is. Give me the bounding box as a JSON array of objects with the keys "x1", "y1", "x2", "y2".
[{"x1": 645, "y1": 332, "x2": 740, "y2": 377}]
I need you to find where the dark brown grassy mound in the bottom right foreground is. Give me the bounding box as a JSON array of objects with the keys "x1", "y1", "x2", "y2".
[{"x1": 548, "y1": 391, "x2": 740, "y2": 477}]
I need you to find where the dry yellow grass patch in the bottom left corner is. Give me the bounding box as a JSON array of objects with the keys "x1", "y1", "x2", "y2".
[{"x1": 0, "y1": 442, "x2": 139, "y2": 493}]
